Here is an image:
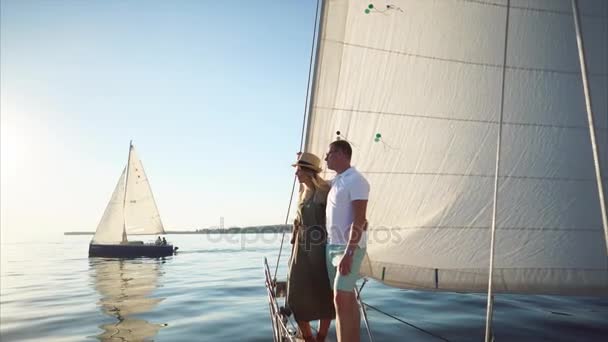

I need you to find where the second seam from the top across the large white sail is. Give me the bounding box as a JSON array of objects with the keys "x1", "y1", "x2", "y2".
[{"x1": 325, "y1": 39, "x2": 608, "y2": 77}]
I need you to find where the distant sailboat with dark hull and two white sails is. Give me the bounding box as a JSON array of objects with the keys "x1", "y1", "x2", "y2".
[{"x1": 89, "y1": 142, "x2": 177, "y2": 258}]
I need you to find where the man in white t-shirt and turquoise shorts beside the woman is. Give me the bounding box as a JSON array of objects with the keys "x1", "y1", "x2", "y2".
[{"x1": 325, "y1": 140, "x2": 369, "y2": 342}]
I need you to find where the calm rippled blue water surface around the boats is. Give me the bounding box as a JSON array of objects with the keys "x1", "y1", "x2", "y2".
[{"x1": 0, "y1": 234, "x2": 608, "y2": 341}]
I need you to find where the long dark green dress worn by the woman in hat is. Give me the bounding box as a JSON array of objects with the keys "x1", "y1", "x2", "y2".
[{"x1": 287, "y1": 193, "x2": 336, "y2": 321}]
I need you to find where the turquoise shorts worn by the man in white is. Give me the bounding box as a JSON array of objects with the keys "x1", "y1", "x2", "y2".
[{"x1": 325, "y1": 244, "x2": 365, "y2": 292}]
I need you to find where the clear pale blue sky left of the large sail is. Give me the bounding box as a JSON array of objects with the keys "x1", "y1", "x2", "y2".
[{"x1": 0, "y1": 0, "x2": 316, "y2": 241}]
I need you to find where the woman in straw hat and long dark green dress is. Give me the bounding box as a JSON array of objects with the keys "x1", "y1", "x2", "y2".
[{"x1": 287, "y1": 152, "x2": 336, "y2": 342}]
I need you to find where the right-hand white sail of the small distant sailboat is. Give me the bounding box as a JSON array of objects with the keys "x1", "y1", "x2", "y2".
[{"x1": 125, "y1": 146, "x2": 165, "y2": 235}]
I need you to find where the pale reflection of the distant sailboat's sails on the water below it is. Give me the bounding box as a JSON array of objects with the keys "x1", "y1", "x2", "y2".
[{"x1": 89, "y1": 258, "x2": 165, "y2": 341}]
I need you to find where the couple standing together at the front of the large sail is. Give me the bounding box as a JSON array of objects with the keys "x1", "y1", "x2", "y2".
[{"x1": 287, "y1": 140, "x2": 369, "y2": 342}]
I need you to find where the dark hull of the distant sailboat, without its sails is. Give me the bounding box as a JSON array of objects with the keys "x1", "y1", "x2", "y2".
[{"x1": 89, "y1": 243, "x2": 177, "y2": 258}]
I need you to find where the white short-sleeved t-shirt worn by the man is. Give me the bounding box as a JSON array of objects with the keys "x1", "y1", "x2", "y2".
[{"x1": 325, "y1": 166, "x2": 369, "y2": 248}]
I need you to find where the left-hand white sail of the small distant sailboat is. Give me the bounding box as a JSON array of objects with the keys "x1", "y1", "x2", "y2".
[{"x1": 92, "y1": 168, "x2": 126, "y2": 244}]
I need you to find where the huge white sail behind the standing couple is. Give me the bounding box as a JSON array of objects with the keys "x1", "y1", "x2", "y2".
[{"x1": 305, "y1": 0, "x2": 608, "y2": 295}]
